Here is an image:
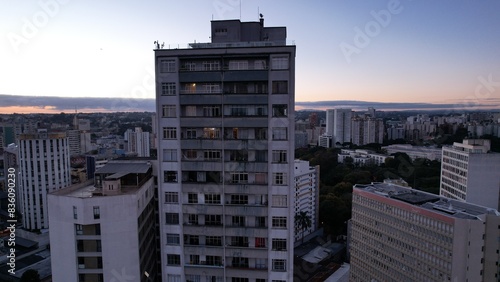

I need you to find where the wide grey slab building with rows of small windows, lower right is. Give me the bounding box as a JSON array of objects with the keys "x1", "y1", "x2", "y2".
[{"x1": 349, "y1": 183, "x2": 500, "y2": 282}]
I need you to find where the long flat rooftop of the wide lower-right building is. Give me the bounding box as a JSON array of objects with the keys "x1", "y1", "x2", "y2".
[{"x1": 354, "y1": 182, "x2": 500, "y2": 220}]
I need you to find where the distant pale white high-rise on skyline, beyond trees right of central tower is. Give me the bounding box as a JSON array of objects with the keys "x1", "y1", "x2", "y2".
[{"x1": 325, "y1": 109, "x2": 352, "y2": 145}]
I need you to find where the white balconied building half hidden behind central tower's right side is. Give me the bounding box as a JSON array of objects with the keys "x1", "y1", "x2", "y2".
[{"x1": 295, "y1": 160, "x2": 319, "y2": 241}]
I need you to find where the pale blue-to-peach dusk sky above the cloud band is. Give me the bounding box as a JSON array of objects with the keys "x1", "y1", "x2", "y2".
[{"x1": 0, "y1": 0, "x2": 500, "y2": 113}]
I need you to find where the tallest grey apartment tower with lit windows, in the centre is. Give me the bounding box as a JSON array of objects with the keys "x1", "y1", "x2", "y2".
[{"x1": 155, "y1": 18, "x2": 295, "y2": 282}]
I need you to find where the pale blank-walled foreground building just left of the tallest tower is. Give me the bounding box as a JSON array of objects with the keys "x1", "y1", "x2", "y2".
[{"x1": 48, "y1": 160, "x2": 157, "y2": 282}]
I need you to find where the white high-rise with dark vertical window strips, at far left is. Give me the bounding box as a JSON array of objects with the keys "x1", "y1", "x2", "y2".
[{"x1": 18, "y1": 129, "x2": 71, "y2": 230}]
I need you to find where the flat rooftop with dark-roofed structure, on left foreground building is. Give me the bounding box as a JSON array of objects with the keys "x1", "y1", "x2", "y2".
[{"x1": 52, "y1": 159, "x2": 153, "y2": 198}]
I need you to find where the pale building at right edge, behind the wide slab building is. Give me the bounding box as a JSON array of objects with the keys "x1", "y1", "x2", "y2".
[{"x1": 439, "y1": 139, "x2": 500, "y2": 210}]
